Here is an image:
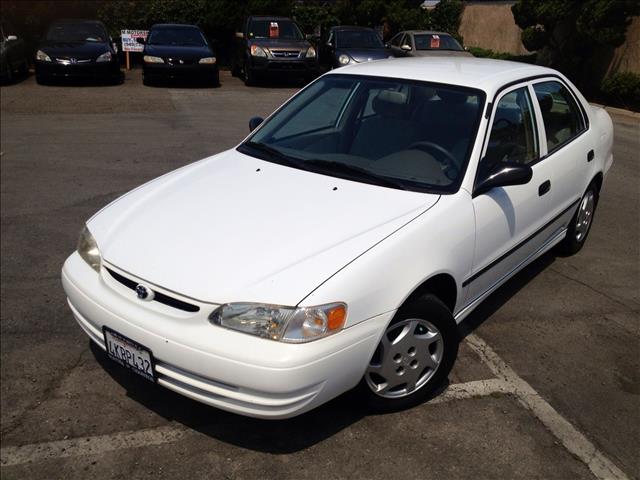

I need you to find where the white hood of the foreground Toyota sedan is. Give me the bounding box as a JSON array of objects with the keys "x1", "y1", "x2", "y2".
[{"x1": 87, "y1": 150, "x2": 439, "y2": 305}]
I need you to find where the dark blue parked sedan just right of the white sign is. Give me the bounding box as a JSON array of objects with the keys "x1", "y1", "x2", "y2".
[{"x1": 138, "y1": 23, "x2": 220, "y2": 85}]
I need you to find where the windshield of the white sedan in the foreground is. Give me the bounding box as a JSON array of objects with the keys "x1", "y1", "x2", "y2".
[{"x1": 238, "y1": 74, "x2": 485, "y2": 193}]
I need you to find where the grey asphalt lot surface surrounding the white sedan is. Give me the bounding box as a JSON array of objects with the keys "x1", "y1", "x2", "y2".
[{"x1": 0, "y1": 71, "x2": 640, "y2": 480}]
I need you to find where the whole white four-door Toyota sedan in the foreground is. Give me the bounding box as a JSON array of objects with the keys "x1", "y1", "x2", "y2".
[{"x1": 62, "y1": 57, "x2": 613, "y2": 418}]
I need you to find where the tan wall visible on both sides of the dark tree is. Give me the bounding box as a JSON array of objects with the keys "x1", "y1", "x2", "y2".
[{"x1": 460, "y1": 1, "x2": 640, "y2": 75}]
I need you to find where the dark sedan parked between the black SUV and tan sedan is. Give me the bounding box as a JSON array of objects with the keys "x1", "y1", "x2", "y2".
[{"x1": 320, "y1": 26, "x2": 391, "y2": 68}]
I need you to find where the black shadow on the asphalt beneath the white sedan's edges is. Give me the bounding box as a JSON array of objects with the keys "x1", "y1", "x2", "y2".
[{"x1": 90, "y1": 253, "x2": 555, "y2": 454}]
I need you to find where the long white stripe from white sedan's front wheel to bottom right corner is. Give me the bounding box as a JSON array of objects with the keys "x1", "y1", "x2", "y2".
[{"x1": 466, "y1": 334, "x2": 628, "y2": 479}]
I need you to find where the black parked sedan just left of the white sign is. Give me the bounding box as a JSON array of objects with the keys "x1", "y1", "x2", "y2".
[{"x1": 35, "y1": 20, "x2": 123, "y2": 84}]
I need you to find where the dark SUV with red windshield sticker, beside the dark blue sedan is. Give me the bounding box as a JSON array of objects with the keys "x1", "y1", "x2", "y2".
[{"x1": 231, "y1": 16, "x2": 319, "y2": 85}]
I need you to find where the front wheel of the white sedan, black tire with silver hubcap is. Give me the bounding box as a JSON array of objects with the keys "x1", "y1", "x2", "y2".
[{"x1": 356, "y1": 294, "x2": 460, "y2": 413}]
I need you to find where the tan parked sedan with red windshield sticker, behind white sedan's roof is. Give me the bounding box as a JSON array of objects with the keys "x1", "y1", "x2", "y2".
[{"x1": 388, "y1": 30, "x2": 473, "y2": 57}]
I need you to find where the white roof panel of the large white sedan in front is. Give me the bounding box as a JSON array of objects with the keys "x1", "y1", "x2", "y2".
[{"x1": 327, "y1": 56, "x2": 564, "y2": 95}]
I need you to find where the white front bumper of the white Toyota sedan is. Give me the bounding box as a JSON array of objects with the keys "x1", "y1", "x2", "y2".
[{"x1": 62, "y1": 252, "x2": 393, "y2": 419}]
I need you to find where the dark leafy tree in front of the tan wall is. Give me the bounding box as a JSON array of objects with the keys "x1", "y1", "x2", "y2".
[{"x1": 511, "y1": 0, "x2": 640, "y2": 92}]
